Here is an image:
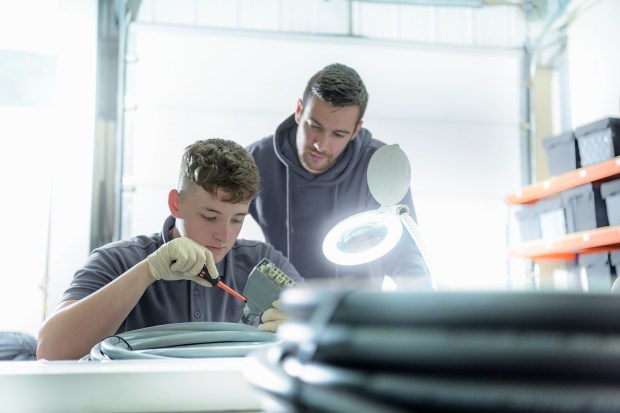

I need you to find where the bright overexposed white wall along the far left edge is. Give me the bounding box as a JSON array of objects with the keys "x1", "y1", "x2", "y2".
[{"x1": 0, "y1": 0, "x2": 97, "y2": 334}]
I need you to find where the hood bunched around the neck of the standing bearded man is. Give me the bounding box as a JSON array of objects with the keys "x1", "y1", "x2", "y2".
[{"x1": 273, "y1": 114, "x2": 372, "y2": 186}]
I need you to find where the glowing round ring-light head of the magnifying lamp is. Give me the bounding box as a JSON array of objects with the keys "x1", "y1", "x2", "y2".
[{"x1": 323, "y1": 208, "x2": 403, "y2": 265}]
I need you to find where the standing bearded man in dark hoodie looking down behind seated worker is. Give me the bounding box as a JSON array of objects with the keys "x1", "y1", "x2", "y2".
[{"x1": 248, "y1": 64, "x2": 431, "y2": 288}]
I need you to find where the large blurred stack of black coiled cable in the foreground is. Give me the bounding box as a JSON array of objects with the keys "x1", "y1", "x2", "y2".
[{"x1": 247, "y1": 289, "x2": 620, "y2": 413}]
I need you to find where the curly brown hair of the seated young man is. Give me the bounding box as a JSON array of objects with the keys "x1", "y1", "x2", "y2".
[{"x1": 179, "y1": 139, "x2": 259, "y2": 204}]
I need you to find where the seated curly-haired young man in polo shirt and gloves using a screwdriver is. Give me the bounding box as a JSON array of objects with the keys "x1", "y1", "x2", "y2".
[{"x1": 37, "y1": 139, "x2": 301, "y2": 360}]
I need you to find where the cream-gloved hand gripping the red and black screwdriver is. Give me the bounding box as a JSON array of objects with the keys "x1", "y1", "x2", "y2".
[{"x1": 146, "y1": 237, "x2": 218, "y2": 287}]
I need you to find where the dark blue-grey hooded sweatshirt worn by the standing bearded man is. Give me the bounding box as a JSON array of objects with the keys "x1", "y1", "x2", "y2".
[{"x1": 247, "y1": 115, "x2": 430, "y2": 285}]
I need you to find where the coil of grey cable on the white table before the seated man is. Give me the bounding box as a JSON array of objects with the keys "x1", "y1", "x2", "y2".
[{"x1": 81, "y1": 322, "x2": 278, "y2": 361}]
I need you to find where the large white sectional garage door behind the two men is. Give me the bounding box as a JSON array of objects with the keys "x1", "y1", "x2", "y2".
[{"x1": 125, "y1": 24, "x2": 520, "y2": 288}]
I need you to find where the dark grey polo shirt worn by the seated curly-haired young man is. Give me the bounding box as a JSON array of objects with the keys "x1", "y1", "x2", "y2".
[{"x1": 63, "y1": 217, "x2": 303, "y2": 334}]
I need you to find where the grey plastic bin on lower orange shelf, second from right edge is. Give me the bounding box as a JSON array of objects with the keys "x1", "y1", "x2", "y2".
[{"x1": 562, "y1": 183, "x2": 609, "y2": 232}]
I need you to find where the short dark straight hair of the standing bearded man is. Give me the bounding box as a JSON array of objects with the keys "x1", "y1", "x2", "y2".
[{"x1": 302, "y1": 63, "x2": 368, "y2": 122}]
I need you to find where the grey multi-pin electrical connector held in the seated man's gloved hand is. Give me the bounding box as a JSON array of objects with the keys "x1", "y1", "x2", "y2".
[{"x1": 241, "y1": 258, "x2": 297, "y2": 324}]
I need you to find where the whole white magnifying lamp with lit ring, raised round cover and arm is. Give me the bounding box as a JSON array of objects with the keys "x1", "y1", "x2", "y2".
[{"x1": 323, "y1": 145, "x2": 430, "y2": 273}]
